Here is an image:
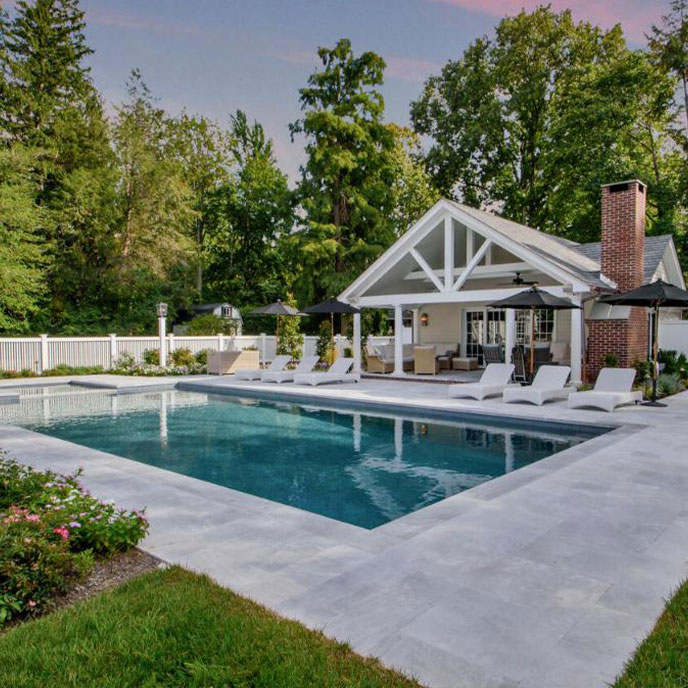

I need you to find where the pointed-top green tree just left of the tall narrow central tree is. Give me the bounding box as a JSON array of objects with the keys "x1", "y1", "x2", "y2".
[{"x1": 202, "y1": 111, "x2": 294, "y2": 305}]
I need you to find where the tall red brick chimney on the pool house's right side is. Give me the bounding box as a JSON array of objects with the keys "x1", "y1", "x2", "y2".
[{"x1": 586, "y1": 179, "x2": 648, "y2": 382}]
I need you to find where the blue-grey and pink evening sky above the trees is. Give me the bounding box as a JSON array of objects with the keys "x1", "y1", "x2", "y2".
[{"x1": 22, "y1": 0, "x2": 669, "y2": 183}]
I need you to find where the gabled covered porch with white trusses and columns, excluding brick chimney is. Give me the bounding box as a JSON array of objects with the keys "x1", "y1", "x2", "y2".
[{"x1": 340, "y1": 201, "x2": 596, "y2": 383}]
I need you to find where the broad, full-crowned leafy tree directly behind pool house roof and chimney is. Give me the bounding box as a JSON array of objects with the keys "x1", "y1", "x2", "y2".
[{"x1": 411, "y1": 7, "x2": 672, "y2": 241}]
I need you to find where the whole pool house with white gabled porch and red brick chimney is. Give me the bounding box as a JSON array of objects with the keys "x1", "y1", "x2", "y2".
[{"x1": 339, "y1": 180, "x2": 685, "y2": 383}]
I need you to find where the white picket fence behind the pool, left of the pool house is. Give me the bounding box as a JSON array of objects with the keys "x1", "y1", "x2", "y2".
[{"x1": 0, "y1": 334, "x2": 392, "y2": 373}]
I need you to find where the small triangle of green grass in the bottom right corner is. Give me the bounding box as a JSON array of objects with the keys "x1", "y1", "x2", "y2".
[{"x1": 614, "y1": 582, "x2": 688, "y2": 688}]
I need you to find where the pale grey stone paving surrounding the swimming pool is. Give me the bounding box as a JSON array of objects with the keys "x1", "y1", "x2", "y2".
[{"x1": 0, "y1": 378, "x2": 688, "y2": 688}]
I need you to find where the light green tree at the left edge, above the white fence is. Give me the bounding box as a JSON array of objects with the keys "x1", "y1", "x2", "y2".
[{"x1": 0, "y1": 146, "x2": 50, "y2": 334}]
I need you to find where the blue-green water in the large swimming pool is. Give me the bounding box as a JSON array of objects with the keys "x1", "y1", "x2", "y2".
[{"x1": 5, "y1": 391, "x2": 605, "y2": 528}]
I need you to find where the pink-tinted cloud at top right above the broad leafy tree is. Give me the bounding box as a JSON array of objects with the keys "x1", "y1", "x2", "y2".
[{"x1": 428, "y1": 0, "x2": 667, "y2": 42}]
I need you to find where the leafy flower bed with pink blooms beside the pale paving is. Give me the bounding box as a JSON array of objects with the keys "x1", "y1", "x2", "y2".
[{"x1": 0, "y1": 457, "x2": 148, "y2": 626}]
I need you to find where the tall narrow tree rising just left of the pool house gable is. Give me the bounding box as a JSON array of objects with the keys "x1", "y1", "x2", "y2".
[{"x1": 290, "y1": 39, "x2": 394, "y2": 300}]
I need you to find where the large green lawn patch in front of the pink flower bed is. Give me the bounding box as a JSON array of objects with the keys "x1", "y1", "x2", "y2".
[{"x1": 0, "y1": 567, "x2": 419, "y2": 688}]
